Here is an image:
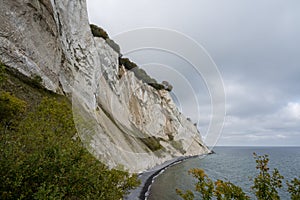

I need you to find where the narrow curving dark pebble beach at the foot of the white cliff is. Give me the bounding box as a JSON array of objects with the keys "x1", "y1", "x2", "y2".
[{"x1": 124, "y1": 153, "x2": 211, "y2": 200}]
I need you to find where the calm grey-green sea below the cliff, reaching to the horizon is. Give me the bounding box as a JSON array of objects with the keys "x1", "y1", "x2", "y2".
[{"x1": 147, "y1": 147, "x2": 300, "y2": 200}]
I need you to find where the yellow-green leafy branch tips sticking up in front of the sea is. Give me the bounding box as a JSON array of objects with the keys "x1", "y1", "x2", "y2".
[{"x1": 176, "y1": 153, "x2": 300, "y2": 200}]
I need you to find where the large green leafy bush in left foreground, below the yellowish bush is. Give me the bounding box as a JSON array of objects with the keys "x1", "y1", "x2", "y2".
[{"x1": 0, "y1": 98, "x2": 138, "y2": 199}]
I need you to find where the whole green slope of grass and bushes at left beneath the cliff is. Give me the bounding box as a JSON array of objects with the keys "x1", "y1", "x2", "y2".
[{"x1": 0, "y1": 65, "x2": 139, "y2": 199}]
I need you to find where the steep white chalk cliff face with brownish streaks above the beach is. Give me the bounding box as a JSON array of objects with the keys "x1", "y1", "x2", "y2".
[{"x1": 0, "y1": 0, "x2": 209, "y2": 172}]
